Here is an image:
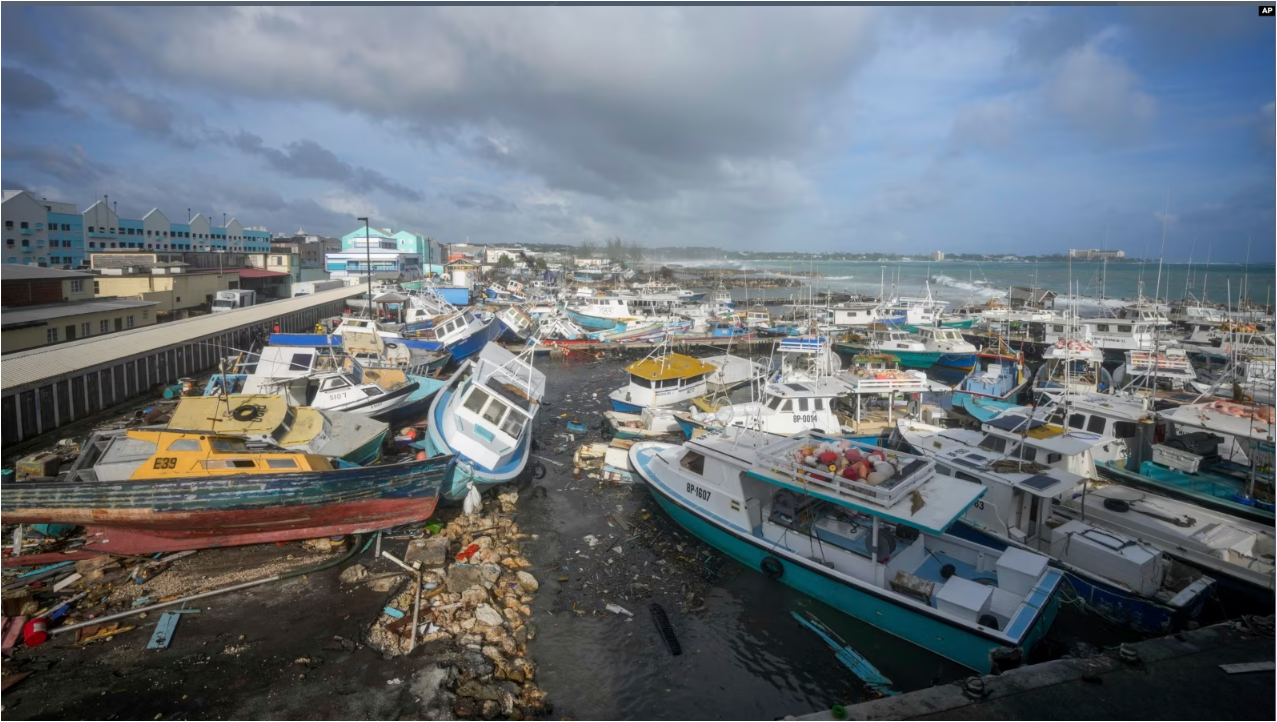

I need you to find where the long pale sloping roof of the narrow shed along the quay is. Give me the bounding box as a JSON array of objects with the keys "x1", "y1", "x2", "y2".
[{"x1": 0, "y1": 286, "x2": 363, "y2": 391}]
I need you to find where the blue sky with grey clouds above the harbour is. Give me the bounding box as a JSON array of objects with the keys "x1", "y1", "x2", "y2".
[{"x1": 0, "y1": 5, "x2": 1277, "y2": 261}]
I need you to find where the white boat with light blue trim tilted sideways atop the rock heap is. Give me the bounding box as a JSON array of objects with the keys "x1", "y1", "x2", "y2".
[{"x1": 414, "y1": 342, "x2": 545, "y2": 500}]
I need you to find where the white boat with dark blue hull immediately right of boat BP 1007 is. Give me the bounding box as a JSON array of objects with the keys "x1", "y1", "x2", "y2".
[{"x1": 899, "y1": 415, "x2": 1213, "y2": 634}]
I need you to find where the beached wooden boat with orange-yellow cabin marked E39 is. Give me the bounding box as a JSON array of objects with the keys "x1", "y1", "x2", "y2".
[{"x1": 0, "y1": 428, "x2": 452, "y2": 555}]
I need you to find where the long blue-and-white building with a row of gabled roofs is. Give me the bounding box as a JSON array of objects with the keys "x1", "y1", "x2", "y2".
[{"x1": 0, "y1": 190, "x2": 271, "y2": 268}]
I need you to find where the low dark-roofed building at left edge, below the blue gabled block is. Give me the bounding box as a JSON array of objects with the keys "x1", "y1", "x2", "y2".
[{"x1": 0, "y1": 263, "x2": 157, "y2": 354}]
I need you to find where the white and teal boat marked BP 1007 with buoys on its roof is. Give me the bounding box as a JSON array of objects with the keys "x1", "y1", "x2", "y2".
[{"x1": 630, "y1": 432, "x2": 1062, "y2": 673}]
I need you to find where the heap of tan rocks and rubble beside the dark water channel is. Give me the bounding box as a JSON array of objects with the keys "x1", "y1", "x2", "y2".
[{"x1": 357, "y1": 489, "x2": 550, "y2": 719}]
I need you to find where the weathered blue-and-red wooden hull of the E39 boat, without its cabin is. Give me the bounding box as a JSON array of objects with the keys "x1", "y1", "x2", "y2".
[{"x1": 0, "y1": 455, "x2": 453, "y2": 553}]
